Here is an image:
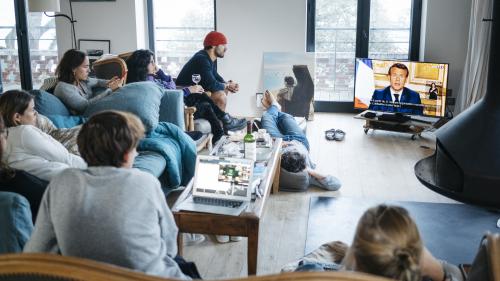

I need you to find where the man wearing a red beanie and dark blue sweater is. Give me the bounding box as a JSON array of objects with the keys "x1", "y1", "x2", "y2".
[{"x1": 176, "y1": 31, "x2": 246, "y2": 128}]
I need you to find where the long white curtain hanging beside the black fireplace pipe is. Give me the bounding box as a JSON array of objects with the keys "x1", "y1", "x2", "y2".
[{"x1": 455, "y1": 0, "x2": 494, "y2": 115}]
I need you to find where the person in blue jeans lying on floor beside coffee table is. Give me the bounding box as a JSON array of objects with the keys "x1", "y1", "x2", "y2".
[{"x1": 261, "y1": 91, "x2": 341, "y2": 191}]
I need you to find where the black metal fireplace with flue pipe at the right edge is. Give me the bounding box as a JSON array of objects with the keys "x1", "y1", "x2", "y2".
[{"x1": 415, "y1": 0, "x2": 500, "y2": 209}]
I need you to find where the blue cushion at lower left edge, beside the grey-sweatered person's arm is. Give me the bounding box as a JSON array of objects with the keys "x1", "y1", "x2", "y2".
[{"x1": 0, "y1": 192, "x2": 33, "y2": 254}]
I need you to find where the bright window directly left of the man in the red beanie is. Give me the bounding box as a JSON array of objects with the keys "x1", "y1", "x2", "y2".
[{"x1": 150, "y1": 0, "x2": 215, "y2": 77}]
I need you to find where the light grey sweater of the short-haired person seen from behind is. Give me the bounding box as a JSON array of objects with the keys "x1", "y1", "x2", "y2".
[{"x1": 24, "y1": 167, "x2": 189, "y2": 279}]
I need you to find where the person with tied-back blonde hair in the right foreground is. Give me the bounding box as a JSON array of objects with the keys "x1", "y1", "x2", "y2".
[{"x1": 283, "y1": 204, "x2": 464, "y2": 281}]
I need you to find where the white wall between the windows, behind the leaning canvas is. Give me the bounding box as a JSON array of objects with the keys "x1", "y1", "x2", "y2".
[{"x1": 216, "y1": 0, "x2": 306, "y2": 116}]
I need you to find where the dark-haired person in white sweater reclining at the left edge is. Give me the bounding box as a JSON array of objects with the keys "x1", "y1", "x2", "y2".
[{"x1": 0, "y1": 90, "x2": 87, "y2": 181}]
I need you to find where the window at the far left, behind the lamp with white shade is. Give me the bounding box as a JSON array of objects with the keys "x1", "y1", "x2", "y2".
[{"x1": 0, "y1": 0, "x2": 58, "y2": 91}]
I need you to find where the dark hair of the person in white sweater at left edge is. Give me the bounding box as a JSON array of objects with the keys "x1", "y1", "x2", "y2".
[{"x1": 0, "y1": 90, "x2": 33, "y2": 128}]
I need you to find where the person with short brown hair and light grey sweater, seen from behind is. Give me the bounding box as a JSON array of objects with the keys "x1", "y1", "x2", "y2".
[{"x1": 24, "y1": 111, "x2": 199, "y2": 279}]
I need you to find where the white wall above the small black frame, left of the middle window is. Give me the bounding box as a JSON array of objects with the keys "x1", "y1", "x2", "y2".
[{"x1": 56, "y1": 0, "x2": 147, "y2": 55}]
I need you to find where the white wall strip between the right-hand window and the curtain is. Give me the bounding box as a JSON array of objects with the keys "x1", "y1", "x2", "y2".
[{"x1": 420, "y1": 0, "x2": 471, "y2": 97}]
